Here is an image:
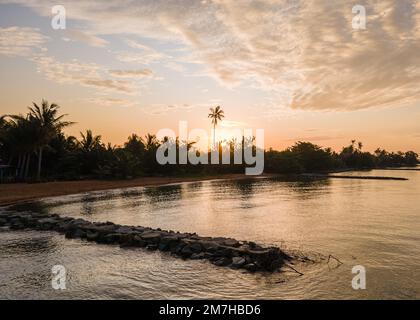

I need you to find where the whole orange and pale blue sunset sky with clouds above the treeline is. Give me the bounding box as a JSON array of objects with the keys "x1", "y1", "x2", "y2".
[{"x1": 0, "y1": 0, "x2": 420, "y2": 152}]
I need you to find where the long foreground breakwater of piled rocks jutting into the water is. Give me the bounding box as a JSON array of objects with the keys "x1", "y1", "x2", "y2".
[{"x1": 0, "y1": 211, "x2": 292, "y2": 272}]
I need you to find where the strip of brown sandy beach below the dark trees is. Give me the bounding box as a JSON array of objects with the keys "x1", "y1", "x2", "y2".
[{"x1": 0, "y1": 174, "x2": 256, "y2": 206}]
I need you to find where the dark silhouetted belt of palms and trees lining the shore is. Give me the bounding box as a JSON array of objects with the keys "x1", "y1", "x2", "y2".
[{"x1": 0, "y1": 101, "x2": 418, "y2": 181}]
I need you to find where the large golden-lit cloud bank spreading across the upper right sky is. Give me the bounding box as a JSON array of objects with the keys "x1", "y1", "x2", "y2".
[{"x1": 2, "y1": 0, "x2": 420, "y2": 111}]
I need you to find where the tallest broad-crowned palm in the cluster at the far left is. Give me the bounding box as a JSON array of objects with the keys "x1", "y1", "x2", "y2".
[{"x1": 29, "y1": 100, "x2": 73, "y2": 180}]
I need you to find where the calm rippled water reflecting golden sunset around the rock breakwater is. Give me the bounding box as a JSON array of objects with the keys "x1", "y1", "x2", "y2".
[{"x1": 0, "y1": 171, "x2": 420, "y2": 299}]
